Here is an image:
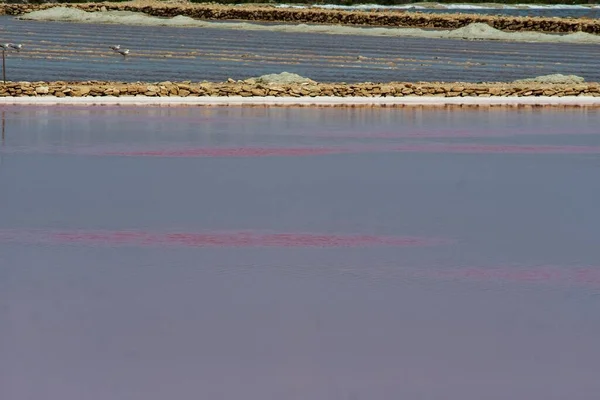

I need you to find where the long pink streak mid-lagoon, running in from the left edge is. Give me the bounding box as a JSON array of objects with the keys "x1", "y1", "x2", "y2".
[{"x1": 0, "y1": 230, "x2": 448, "y2": 248}]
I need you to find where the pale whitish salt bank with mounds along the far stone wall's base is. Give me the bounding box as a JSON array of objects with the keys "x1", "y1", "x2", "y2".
[{"x1": 19, "y1": 7, "x2": 600, "y2": 43}]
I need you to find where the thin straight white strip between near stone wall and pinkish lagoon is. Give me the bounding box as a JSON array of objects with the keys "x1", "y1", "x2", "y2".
[{"x1": 0, "y1": 96, "x2": 600, "y2": 107}]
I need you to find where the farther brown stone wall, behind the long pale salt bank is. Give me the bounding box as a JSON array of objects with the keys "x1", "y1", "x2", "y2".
[{"x1": 0, "y1": 1, "x2": 600, "y2": 34}]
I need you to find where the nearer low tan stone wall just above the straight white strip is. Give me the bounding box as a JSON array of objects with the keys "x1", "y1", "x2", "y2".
[{"x1": 0, "y1": 79, "x2": 600, "y2": 97}]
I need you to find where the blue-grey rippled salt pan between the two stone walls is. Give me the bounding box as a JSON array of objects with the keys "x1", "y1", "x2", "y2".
[{"x1": 0, "y1": 16, "x2": 600, "y2": 83}]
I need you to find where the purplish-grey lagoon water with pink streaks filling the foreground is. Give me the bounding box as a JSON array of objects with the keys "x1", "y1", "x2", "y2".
[{"x1": 0, "y1": 106, "x2": 600, "y2": 400}]
